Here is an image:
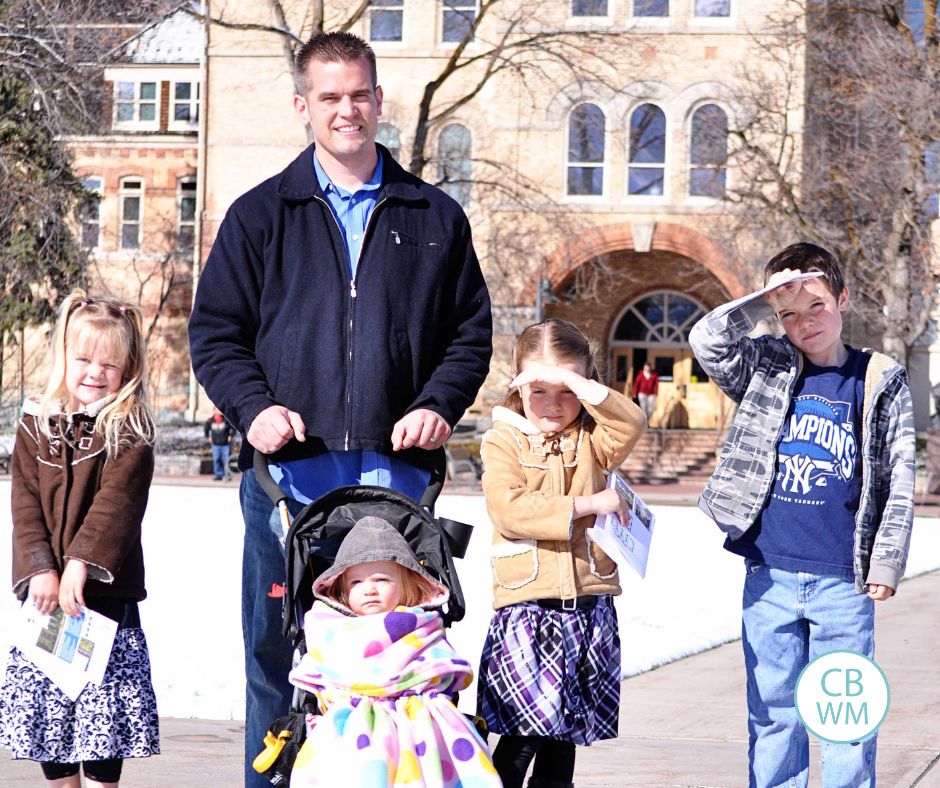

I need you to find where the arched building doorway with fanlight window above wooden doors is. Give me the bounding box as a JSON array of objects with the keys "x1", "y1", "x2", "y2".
[{"x1": 608, "y1": 290, "x2": 720, "y2": 429}]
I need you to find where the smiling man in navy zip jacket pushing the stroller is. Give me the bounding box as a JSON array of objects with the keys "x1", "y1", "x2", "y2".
[{"x1": 190, "y1": 33, "x2": 491, "y2": 787}]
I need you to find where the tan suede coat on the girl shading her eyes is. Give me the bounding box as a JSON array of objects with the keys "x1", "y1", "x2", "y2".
[{"x1": 481, "y1": 383, "x2": 646, "y2": 610}]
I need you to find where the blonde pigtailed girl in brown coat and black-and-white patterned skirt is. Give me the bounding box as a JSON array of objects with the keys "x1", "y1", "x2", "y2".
[{"x1": 0, "y1": 290, "x2": 160, "y2": 788}]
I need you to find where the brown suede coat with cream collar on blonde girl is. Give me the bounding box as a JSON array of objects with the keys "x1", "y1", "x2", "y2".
[{"x1": 11, "y1": 401, "x2": 153, "y2": 601}]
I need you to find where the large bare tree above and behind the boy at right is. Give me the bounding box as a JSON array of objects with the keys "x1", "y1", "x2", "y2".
[{"x1": 716, "y1": 0, "x2": 940, "y2": 362}]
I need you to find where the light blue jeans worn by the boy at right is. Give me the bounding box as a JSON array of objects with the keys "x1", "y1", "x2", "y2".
[{"x1": 742, "y1": 560, "x2": 877, "y2": 788}]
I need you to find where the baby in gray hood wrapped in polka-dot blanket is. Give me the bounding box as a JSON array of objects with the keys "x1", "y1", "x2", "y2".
[{"x1": 290, "y1": 516, "x2": 501, "y2": 788}]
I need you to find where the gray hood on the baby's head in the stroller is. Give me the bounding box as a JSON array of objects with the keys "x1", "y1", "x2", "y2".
[{"x1": 313, "y1": 516, "x2": 450, "y2": 613}]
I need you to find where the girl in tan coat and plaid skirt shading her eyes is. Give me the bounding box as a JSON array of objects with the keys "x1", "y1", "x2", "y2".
[{"x1": 478, "y1": 319, "x2": 646, "y2": 788}]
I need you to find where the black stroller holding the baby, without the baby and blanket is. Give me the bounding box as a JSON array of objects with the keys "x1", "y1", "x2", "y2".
[{"x1": 248, "y1": 452, "x2": 472, "y2": 785}]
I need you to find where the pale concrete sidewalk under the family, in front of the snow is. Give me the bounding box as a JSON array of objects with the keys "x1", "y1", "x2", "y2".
[{"x1": 0, "y1": 571, "x2": 940, "y2": 788}]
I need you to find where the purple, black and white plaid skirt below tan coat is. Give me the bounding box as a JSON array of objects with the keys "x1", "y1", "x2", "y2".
[{"x1": 477, "y1": 596, "x2": 620, "y2": 744}]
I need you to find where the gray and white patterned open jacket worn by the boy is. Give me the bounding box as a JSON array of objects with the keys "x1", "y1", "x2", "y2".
[{"x1": 689, "y1": 295, "x2": 914, "y2": 593}]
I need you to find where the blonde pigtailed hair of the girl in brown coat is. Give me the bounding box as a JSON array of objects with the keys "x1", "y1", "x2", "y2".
[{"x1": 39, "y1": 289, "x2": 155, "y2": 456}]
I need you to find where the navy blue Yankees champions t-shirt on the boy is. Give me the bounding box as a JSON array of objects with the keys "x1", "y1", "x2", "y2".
[{"x1": 725, "y1": 348, "x2": 870, "y2": 579}]
